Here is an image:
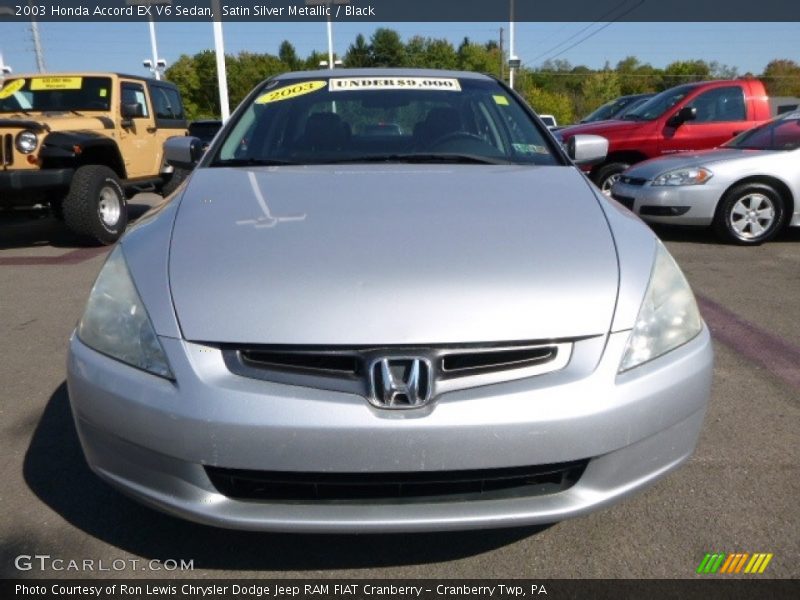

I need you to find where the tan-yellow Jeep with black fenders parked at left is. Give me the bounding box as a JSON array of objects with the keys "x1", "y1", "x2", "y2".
[{"x1": 0, "y1": 73, "x2": 187, "y2": 244}]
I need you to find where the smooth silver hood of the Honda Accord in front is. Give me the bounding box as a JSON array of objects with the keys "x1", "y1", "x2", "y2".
[{"x1": 169, "y1": 165, "x2": 619, "y2": 345}]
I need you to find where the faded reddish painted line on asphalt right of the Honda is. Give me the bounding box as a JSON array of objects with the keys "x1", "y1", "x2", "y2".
[{"x1": 697, "y1": 295, "x2": 800, "y2": 389}]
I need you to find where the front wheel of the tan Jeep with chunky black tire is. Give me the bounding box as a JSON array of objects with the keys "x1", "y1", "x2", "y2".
[{"x1": 63, "y1": 165, "x2": 128, "y2": 244}]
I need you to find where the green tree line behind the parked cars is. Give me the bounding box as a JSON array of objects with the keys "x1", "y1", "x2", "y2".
[{"x1": 166, "y1": 28, "x2": 800, "y2": 123}]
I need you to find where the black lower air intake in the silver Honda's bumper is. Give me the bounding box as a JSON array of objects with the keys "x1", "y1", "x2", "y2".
[{"x1": 205, "y1": 460, "x2": 589, "y2": 503}]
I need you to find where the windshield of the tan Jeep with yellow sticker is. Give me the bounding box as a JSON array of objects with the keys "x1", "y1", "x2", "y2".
[{"x1": 0, "y1": 77, "x2": 111, "y2": 113}]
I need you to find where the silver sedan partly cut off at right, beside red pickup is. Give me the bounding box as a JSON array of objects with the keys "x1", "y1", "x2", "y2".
[{"x1": 611, "y1": 112, "x2": 800, "y2": 245}]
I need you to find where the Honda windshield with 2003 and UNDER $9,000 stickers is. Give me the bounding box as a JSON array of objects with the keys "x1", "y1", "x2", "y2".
[{"x1": 210, "y1": 76, "x2": 563, "y2": 166}]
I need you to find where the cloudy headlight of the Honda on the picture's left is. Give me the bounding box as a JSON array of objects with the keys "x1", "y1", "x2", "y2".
[{"x1": 78, "y1": 246, "x2": 173, "y2": 379}]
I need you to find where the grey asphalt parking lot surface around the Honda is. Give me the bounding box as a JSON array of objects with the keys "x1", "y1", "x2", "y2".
[{"x1": 0, "y1": 196, "x2": 800, "y2": 578}]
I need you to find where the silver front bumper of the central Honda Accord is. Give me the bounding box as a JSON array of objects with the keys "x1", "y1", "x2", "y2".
[{"x1": 68, "y1": 329, "x2": 713, "y2": 532}]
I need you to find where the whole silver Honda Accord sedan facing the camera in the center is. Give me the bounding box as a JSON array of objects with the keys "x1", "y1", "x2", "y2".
[{"x1": 68, "y1": 69, "x2": 712, "y2": 532}]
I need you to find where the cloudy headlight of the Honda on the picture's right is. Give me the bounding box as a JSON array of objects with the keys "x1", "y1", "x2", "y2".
[{"x1": 619, "y1": 243, "x2": 703, "y2": 372}]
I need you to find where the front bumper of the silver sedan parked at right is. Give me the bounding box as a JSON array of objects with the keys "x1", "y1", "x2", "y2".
[{"x1": 611, "y1": 179, "x2": 725, "y2": 226}]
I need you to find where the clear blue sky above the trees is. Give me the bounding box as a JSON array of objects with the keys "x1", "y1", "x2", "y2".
[{"x1": 0, "y1": 22, "x2": 800, "y2": 75}]
